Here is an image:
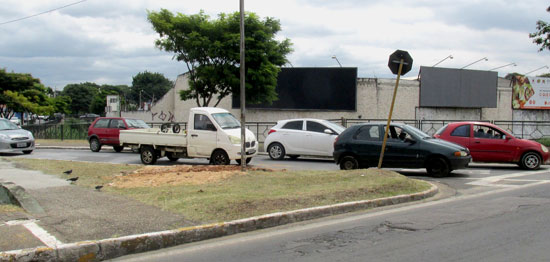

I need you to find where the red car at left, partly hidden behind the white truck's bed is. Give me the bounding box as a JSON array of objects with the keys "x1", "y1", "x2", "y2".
[{"x1": 88, "y1": 117, "x2": 149, "y2": 152}]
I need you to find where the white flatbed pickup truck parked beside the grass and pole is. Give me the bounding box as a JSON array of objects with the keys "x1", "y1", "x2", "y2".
[{"x1": 119, "y1": 107, "x2": 258, "y2": 165}]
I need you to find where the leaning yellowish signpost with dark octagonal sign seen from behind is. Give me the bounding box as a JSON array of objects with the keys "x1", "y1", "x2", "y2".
[{"x1": 378, "y1": 50, "x2": 413, "y2": 169}]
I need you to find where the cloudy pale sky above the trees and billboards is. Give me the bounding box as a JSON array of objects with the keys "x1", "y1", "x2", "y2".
[{"x1": 0, "y1": 0, "x2": 550, "y2": 90}]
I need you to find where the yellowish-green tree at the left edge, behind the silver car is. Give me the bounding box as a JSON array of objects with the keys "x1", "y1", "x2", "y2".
[{"x1": 0, "y1": 69, "x2": 55, "y2": 119}]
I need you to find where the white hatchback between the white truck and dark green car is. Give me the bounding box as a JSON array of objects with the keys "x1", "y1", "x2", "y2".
[{"x1": 264, "y1": 118, "x2": 345, "y2": 160}]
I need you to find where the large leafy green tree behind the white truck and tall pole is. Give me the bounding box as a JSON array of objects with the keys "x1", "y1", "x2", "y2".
[{"x1": 148, "y1": 9, "x2": 292, "y2": 106}]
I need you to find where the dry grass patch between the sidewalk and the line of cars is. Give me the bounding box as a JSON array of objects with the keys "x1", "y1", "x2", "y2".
[{"x1": 6, "y1": 158, "x2": 430, "y2": 223}]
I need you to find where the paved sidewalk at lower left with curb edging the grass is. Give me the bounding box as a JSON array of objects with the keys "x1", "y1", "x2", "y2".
[{"x1": 0, "y1": 146, "x2": 438, "y2": 261}]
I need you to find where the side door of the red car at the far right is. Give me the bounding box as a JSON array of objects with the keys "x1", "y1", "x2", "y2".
[{"x1": 469, "y1": 125, "x2": 516, "y2": 162}]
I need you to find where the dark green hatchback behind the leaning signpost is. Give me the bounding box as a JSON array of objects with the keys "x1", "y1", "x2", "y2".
[{"x1": 333, "y1": 123, "x2": 472, "y2": 177}]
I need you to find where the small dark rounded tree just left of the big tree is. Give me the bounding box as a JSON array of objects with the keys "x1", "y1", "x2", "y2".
[{"x1": 128, "y1": 71, "x2": 174, "y2": 104}]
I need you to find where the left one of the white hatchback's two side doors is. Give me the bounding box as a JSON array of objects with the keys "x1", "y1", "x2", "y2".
[{"x1": 277, "y1": 120, "x2": 307, "y2": 155}]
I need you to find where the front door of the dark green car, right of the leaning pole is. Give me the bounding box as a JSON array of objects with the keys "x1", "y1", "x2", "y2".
[{"x1": 382, "y1": 126, "x2": 424, "y2": 168}]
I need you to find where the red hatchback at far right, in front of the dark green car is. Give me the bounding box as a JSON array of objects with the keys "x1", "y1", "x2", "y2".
[{"x1": 434, "y1": 122, "x2": 549, "y2": 170}]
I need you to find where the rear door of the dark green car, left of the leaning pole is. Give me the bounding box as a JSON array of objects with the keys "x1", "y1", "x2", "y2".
[{"x1": 352, "y1": 124, "x2": 382, "y2": 167}]
